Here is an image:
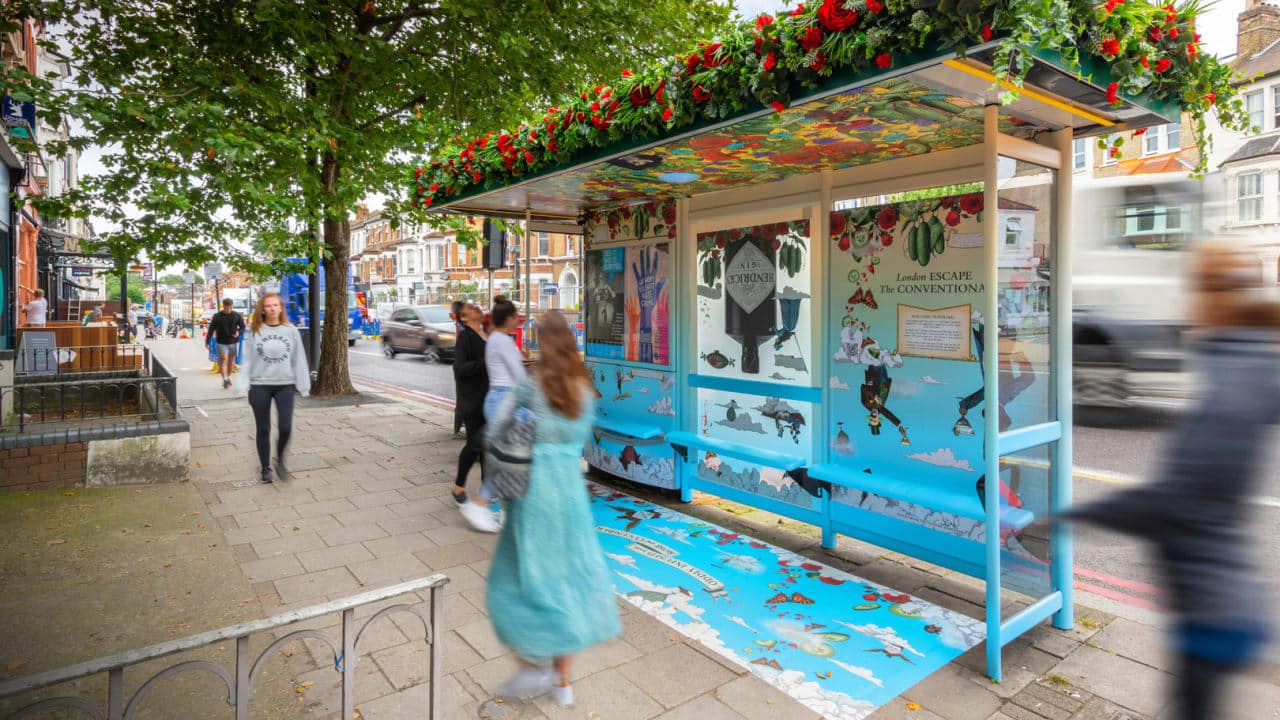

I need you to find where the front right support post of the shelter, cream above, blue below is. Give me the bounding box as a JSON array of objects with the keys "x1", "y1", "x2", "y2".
[{"x1": 982, "y1": 105, "x2": 1004, "y2": 682}]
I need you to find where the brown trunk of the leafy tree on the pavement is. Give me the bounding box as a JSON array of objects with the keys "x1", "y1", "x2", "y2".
[{"x1": 311, "y1": 154, "x2": 356, "y2": 396}]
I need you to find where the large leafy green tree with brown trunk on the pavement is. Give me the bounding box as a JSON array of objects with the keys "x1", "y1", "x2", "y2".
[{"x1": 0, "y1": 0, "x2": 728, "y2": 395}]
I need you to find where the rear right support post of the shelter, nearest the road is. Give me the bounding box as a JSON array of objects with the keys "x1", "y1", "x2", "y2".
[{"x1": 1050, "y1": 128, "x2": 1075, "y2": 630}]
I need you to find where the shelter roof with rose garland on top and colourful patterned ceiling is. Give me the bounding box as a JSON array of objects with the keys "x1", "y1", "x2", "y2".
[{"x1": 413, "y1": 0, "x2": 1249, "y2": 217}]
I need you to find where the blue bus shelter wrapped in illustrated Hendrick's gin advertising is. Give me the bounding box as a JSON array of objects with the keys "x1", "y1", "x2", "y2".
[{"x1": 417, "y1": 9, "x2": 1213, "y2": 679}]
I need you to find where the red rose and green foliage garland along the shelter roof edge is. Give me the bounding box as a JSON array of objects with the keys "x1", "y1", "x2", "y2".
[{"x1": 415, "y1": 0, "x2": 1249, "y2": 208}]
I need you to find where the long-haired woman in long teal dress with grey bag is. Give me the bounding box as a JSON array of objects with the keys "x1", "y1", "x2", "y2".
[{"x1": 488, "y1": 311, "x2": 622, "y2": 705}]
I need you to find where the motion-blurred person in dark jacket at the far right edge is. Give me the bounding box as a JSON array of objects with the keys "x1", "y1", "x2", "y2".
[{"x1": 1065, "y1": 243, "x2": 1280, "y2": 720}]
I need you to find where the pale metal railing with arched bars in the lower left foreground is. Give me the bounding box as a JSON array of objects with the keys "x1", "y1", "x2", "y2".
[{"x1": 0, "y1": 575, "x2": 449, "y2": 720}]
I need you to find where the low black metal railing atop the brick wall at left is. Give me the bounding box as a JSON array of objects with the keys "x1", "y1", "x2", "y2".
[{"x1": 0, "y1": 365, "x2": 178, "y2": 432}]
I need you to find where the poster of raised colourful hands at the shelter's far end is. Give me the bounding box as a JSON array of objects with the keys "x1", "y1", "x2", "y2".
[{"x1": 625, "y1": 242, "x2": 671, "y2": 365}]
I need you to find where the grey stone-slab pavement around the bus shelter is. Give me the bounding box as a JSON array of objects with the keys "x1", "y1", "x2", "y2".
[{"x1": 151, "y1": 340, "x2": 1280, "y2": 720}]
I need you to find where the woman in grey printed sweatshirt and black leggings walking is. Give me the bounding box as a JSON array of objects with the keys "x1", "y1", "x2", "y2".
[{"x1": 237, "y1": 292, "x2": 311, "y2": 483}]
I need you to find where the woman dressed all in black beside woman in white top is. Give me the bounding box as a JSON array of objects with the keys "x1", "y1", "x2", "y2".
[{"x1": 453, "y1": 299, "x2": 499, "y2": 533}]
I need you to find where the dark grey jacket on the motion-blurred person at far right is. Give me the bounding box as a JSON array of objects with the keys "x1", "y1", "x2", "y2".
[{"x1": 1066, "y1": 329, "x2": 1280, "y2": 632}]
